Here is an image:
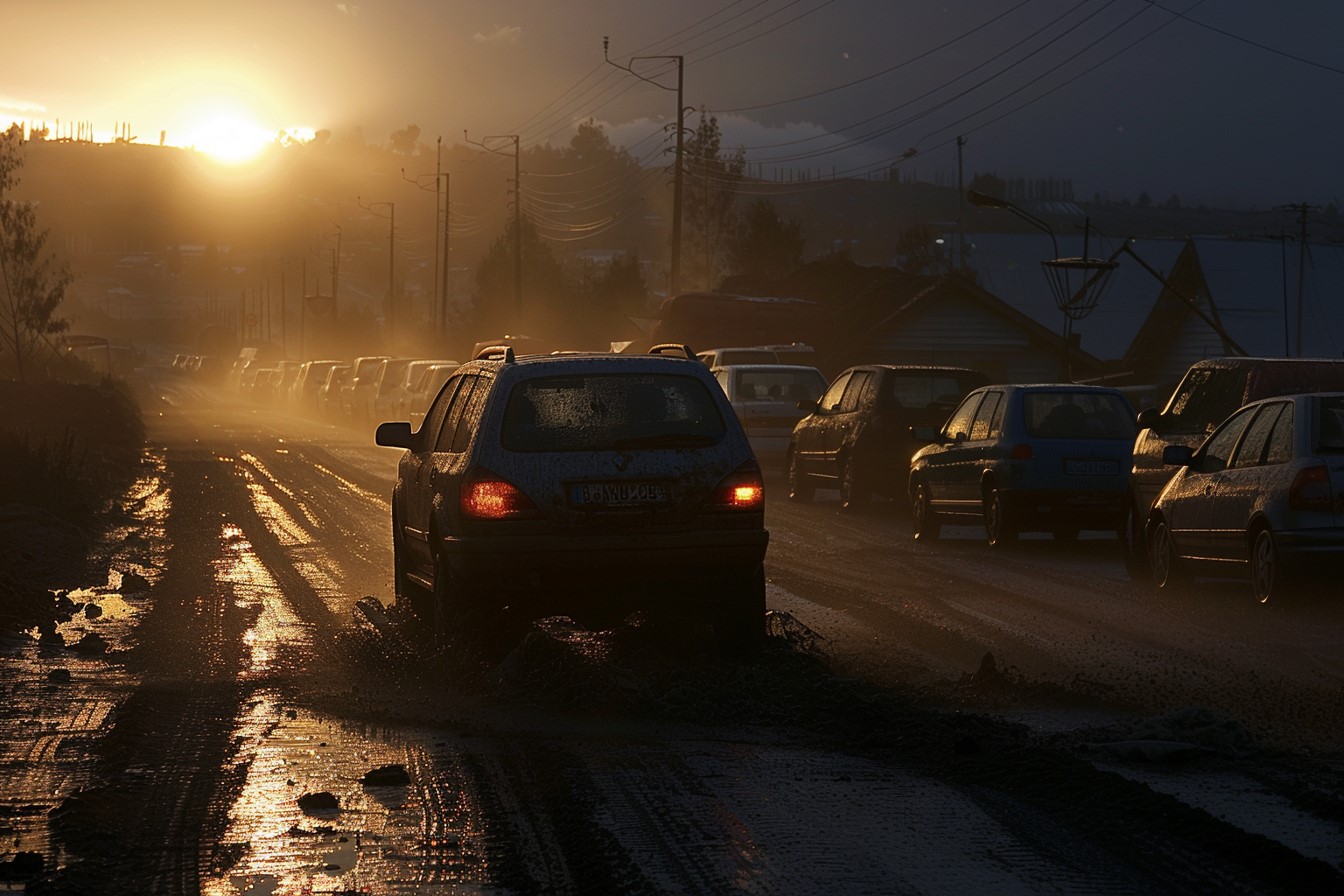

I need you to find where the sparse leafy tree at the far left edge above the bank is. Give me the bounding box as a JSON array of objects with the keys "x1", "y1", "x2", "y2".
[{"x1": 0, "y1": 125, "x2": 73, "y2": 380}]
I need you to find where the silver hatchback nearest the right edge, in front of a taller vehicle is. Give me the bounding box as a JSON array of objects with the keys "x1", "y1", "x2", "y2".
[{"x1": 1146, "y1": 392, "x2": 1344, "y2": 602}]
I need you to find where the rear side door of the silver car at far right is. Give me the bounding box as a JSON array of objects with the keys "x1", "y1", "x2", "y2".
[{"x1": 1210, "y1": 402, "x2": 1293, "y2": 560}]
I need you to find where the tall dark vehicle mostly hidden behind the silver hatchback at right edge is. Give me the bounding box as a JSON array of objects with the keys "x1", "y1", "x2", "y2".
[{"x1": 1128, "y1": 357, "x2": 1344, "y2": 576}]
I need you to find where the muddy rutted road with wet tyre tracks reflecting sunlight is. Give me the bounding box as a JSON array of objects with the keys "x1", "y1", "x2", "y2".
[{"x1": 0, "y1": 375, "x2": 1344, "y2": 896}]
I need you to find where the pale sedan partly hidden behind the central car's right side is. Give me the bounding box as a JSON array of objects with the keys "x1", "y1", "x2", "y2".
[{"x1": 711, "y1": 363, "x2": 827, "y2": 470}]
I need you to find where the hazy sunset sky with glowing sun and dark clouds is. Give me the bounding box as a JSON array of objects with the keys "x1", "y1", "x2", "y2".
[{"x1": 0, "y1": 0, "x2": 1344, "y2": 207}]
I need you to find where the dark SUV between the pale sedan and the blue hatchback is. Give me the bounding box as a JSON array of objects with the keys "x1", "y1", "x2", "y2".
[{"x1": 785, "y1": 364, "x2": 989, "y2": 510}]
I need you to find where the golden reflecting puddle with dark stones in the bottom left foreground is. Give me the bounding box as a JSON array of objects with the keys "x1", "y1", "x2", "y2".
[{"x1": 200, "y1": 692, "x2": 497, "y2": 896}]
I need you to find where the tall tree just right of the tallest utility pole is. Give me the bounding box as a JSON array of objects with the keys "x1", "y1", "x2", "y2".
[{"x1": 681, "y1": 111, "x2": 747, "y2": 289}]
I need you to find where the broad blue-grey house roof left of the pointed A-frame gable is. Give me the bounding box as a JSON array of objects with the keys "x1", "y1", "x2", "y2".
[{"x1": 953, "y1": 234, "x2": 1185, "y2": 361}]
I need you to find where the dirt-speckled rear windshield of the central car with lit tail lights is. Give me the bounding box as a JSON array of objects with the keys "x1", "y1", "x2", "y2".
[{"x1": 500, "y1": 373, "x2": 726, "y2": 451}]
